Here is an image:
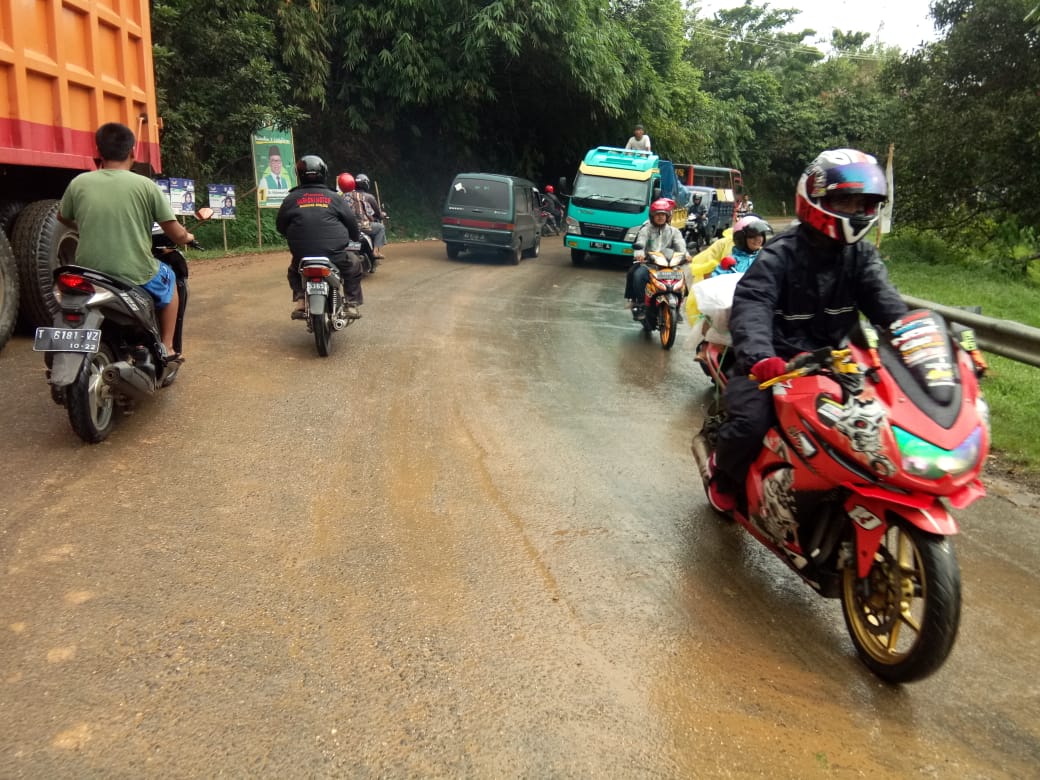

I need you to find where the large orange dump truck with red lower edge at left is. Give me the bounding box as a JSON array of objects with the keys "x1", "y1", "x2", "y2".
[{"x1": 0, "y1": 0, "x2": 161, "y2": 348}]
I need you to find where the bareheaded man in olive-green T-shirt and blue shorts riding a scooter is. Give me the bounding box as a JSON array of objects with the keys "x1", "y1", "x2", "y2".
[{"x1": 58, "y1": 122, "x2": 194, "y2": 360}]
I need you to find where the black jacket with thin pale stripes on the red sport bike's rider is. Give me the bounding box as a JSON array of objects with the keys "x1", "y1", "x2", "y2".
[{"x1": 730, "y1": 225, "x2": 907, "y2": 371}]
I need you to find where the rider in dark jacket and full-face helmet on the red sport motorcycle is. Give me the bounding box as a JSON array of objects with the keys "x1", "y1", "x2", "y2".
[{"x1": 707, "y1": 149, "x2": 907, "y2": 513}]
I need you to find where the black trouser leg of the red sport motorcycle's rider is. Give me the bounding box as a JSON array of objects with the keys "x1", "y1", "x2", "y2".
[{"x1": 716, "y1": 373, "x2": 776, "y2": 492}]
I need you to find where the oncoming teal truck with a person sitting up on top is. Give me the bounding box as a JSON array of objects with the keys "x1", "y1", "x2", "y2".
[{"x1": 561, "y1": 147, "x2": 677, "y2": 265}]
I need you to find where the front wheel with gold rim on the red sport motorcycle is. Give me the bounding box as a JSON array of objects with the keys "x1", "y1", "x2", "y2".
[{"x1": 841, "y1": 522, "x2": 961, "y2": 682}]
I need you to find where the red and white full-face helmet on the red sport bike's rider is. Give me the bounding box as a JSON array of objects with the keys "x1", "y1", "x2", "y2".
[{"x1": 795, "y1": 149, "x2": 888, "y2": 244}]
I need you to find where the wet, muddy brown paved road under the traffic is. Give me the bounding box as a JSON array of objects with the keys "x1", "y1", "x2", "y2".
[{"x1": 0, "y1": 239, "x2": 1040, "y2": 778}]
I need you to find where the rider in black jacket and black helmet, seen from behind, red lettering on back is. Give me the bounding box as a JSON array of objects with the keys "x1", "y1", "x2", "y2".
[{"x1": 276, "y1": 154, "x2": 363, "y2": 319}]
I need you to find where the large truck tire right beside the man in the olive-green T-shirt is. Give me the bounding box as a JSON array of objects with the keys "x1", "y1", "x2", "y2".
[{"x1": 10, "y1": 200, "x2": 79, "y2": 327}]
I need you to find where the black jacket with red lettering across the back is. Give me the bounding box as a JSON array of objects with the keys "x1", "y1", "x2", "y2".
[{"x1": 275, "y1": 184, "x2": 361, "y2": 260}]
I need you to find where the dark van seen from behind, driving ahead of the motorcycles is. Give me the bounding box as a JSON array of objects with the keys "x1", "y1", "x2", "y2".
[{"x1": 441, "y1": 174, "x2": 542, "y2": 265}]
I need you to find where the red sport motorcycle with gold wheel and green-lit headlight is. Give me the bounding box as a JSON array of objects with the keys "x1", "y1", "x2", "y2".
[{"x1": 693, "y1": 310, "x2": 990, "y2": 682}]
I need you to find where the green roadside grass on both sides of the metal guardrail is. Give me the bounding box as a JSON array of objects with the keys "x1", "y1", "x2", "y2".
[{"x1": 881, "y1": 230, "x2": 1040, "y2": 484}]
